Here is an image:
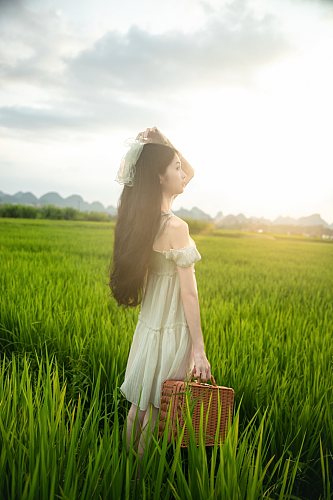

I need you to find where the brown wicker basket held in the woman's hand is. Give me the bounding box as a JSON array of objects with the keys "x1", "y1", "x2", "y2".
[{"x1": 158, "y1": 376, "x2": 235, "y2": 448}]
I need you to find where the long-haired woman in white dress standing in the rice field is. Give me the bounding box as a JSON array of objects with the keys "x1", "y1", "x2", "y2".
[{"x1": 110, "y1": 127, "x2": 211, "y2": 458}]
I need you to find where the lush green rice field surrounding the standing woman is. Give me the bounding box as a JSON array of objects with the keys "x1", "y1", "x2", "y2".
[{"x1": 0, "y1": 219, "x2": 333, "y2": 500}]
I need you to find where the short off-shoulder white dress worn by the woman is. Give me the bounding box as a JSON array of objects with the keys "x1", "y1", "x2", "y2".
[{"x1": 120, "y1": 211, "x2": 201, "y2": 410}]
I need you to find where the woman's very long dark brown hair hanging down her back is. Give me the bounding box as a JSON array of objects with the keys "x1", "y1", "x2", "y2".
[{"x1": 109, "y1": 143, "x2": 177, "y2": 307}]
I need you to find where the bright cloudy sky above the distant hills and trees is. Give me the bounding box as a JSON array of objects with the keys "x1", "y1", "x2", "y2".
[{"x1": 0, "y1": 0, "x2": 333, "y2": 224}]
